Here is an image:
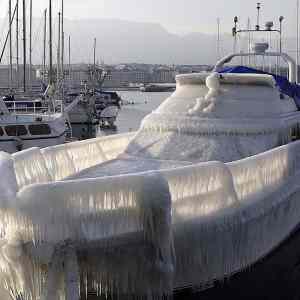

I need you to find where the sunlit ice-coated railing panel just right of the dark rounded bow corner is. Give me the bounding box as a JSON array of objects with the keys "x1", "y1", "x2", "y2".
[{"x1": 159, "y1": 162, "x2": 238, "y2": 216}]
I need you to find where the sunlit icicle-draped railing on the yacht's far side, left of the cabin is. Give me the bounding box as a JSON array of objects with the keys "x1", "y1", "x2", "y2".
[{"x1": 12, "y1": 133, "x2": 134, "y2": 189}]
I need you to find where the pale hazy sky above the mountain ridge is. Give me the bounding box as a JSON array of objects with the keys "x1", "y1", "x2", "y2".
[{"x1": 0, "y1": 0, "x2": 296, "y2": 36}]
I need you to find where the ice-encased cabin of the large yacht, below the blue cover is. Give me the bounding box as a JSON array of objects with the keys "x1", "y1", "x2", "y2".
[{"x1": 127, "y1": 73, "x2": 300, "y2": 162}]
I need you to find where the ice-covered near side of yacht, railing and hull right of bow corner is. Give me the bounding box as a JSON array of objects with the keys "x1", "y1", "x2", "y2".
[{"x1": 161, "y1": 142, "x2": 300, "y2": 287}]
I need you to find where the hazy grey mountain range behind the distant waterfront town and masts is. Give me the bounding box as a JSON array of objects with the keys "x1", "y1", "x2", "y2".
[{"x1": 0, "y1": 19, "x2": 294, "y2": 64}]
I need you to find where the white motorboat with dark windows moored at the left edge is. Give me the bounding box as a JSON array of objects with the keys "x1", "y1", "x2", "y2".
[{"x1": 0, "y1": 99, "x2": 66, "y2": 153}]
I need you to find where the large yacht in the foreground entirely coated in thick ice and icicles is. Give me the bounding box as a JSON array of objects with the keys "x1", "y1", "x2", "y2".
[{"x1": 0, "y1": 15, "x2": 300, "y2": 300}]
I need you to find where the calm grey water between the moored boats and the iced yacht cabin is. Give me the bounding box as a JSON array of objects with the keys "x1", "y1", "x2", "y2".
[{"x1": 97, "y1": 91, "x2": 171, "y2": 136}]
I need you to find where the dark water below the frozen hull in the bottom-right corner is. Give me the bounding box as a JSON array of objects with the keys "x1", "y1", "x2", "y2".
[{"x1": 174, "y1": 226, "x2": 300, "y2": 300}]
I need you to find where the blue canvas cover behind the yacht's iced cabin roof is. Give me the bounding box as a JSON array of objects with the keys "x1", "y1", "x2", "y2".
[{"x1": 219, "y1": 66, "x2": 300, "y2": 110}]
